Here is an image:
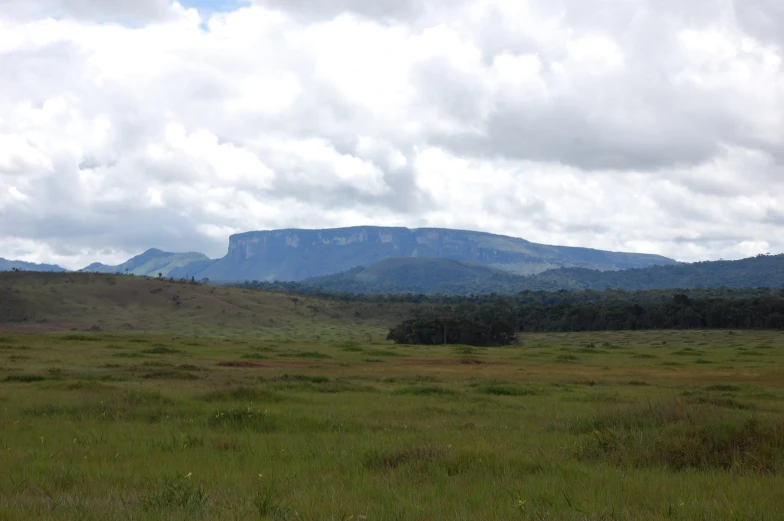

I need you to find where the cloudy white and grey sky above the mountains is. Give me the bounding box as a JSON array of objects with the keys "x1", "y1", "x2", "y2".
[{"x1": 0, "y1": 0, "x2": 784, "y2": 268}]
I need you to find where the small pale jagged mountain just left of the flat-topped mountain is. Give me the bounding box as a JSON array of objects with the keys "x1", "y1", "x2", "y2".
[{"x1": 81, "y1": 248, "x2": 214, "y2": 278}]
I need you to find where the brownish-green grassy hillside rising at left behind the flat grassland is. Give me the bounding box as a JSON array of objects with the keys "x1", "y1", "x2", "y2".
[{"x1": 0, "y1": 272, "x2": 410, "y2": 340}]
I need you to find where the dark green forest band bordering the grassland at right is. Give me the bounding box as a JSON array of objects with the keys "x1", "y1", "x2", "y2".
[{"x1": 388, "y1": 291, "x2": 784, "y2": 346}]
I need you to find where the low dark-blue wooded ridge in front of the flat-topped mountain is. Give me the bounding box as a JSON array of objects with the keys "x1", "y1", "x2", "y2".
[{"x1": 292, "y1": 255, "x2": 784, "y2": 295}]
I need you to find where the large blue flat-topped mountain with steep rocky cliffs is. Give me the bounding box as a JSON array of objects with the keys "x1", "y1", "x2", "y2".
[{"x1": 197, "y1": 226, "x2": 675, "y2": 281}]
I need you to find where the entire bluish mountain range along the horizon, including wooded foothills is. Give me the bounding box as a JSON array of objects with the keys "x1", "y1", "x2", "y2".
[{"x1": 0, "y1": 226, "x2": 784, "y2": 295}]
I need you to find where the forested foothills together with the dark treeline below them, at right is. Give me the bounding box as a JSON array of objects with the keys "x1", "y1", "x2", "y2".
[{"x1": 230, "y1": 255, "x2": 784, "y2": 346}]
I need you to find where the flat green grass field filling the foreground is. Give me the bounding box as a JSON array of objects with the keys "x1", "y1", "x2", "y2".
[{"x1": 0, "y1": 328, "x2": 784, "y2": 520}]
